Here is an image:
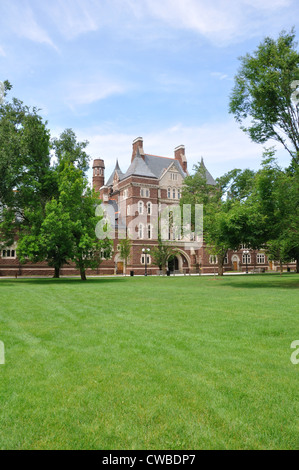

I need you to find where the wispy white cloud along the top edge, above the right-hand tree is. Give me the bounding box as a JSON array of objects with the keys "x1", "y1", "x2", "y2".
[{"x1": 127, "y1": 0, "x2": 297, "y2": 46}]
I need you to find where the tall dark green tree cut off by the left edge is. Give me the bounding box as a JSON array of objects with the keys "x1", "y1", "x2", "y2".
[{"x1": 0, "y1": 82, "x2": 57, "y2": 252}]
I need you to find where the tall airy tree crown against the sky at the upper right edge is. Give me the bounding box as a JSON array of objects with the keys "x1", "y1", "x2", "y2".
[{"x1": 229, "y1": 30, "x2": 299, "y2": 163}]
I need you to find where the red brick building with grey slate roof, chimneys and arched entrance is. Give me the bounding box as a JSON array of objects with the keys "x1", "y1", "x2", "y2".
[{"x1": 0, "y1": 137, "x2": 295, "y2": 276}]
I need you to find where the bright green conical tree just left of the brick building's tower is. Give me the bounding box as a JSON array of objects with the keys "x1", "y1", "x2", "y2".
[{"x1": 17, "y1": 129, "x2": 111, "y2": 280}]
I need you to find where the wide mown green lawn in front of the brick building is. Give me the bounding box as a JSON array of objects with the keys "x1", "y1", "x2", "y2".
[{"x1": 0, "y1": 274, "x2": 299, "y2": 449}]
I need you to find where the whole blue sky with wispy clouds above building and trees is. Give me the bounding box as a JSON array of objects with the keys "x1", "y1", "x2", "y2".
[{"x1": 0, "y1": 0, "x2": 299, "y2": 182}]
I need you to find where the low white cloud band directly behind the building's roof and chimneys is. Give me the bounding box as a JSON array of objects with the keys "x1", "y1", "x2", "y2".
[{"x1": 77, "y1": 119, "x2": 289, "y2": 185}]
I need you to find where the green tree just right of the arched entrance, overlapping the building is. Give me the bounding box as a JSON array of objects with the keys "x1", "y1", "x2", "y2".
[{"x1": 181, "y1": 164, "x2": 255, "y2": 276}]
